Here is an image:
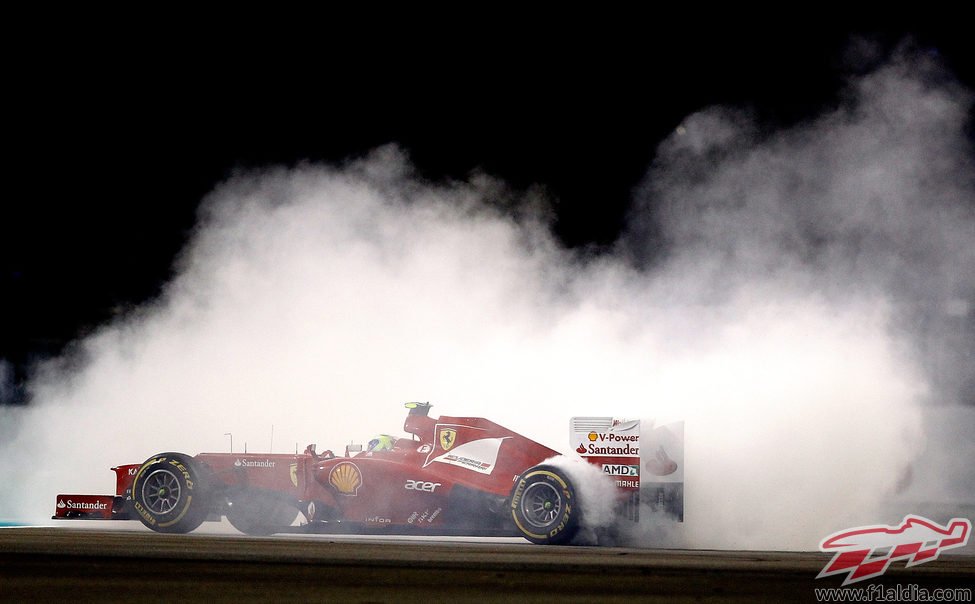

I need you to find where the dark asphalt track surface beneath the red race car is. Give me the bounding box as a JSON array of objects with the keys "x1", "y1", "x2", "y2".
[{"x1": 0, "y1": 527, "x2": 975, "y2": 604}]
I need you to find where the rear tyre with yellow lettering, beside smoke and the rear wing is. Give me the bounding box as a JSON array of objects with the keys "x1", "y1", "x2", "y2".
[{"x1": 509, "y1": 466, "x2": 580, "y2": 545}]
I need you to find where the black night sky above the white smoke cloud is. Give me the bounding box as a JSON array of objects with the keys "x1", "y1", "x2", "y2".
[{"x1": 0, "y1": 15, "x2": 975, "y2": 402}]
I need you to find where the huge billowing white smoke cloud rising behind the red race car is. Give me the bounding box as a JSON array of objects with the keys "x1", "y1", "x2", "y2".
[{"x1": 0, "y1": 44, "x2": 975, "y2": 549}]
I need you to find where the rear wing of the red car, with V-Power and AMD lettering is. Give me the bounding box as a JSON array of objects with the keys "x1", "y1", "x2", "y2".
[{"x1": 569, "y1": 417, "x2": 684, "y2": 522}]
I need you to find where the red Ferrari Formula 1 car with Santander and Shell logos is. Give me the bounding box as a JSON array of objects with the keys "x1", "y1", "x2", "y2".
[{"x1": 54, "y1": 403, "x2": 683, "y2": 544}]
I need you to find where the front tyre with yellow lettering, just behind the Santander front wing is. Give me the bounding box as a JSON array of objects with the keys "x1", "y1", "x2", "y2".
[{"x1": 132, "y1": 453, "x2": 210, "y2": 533}]
